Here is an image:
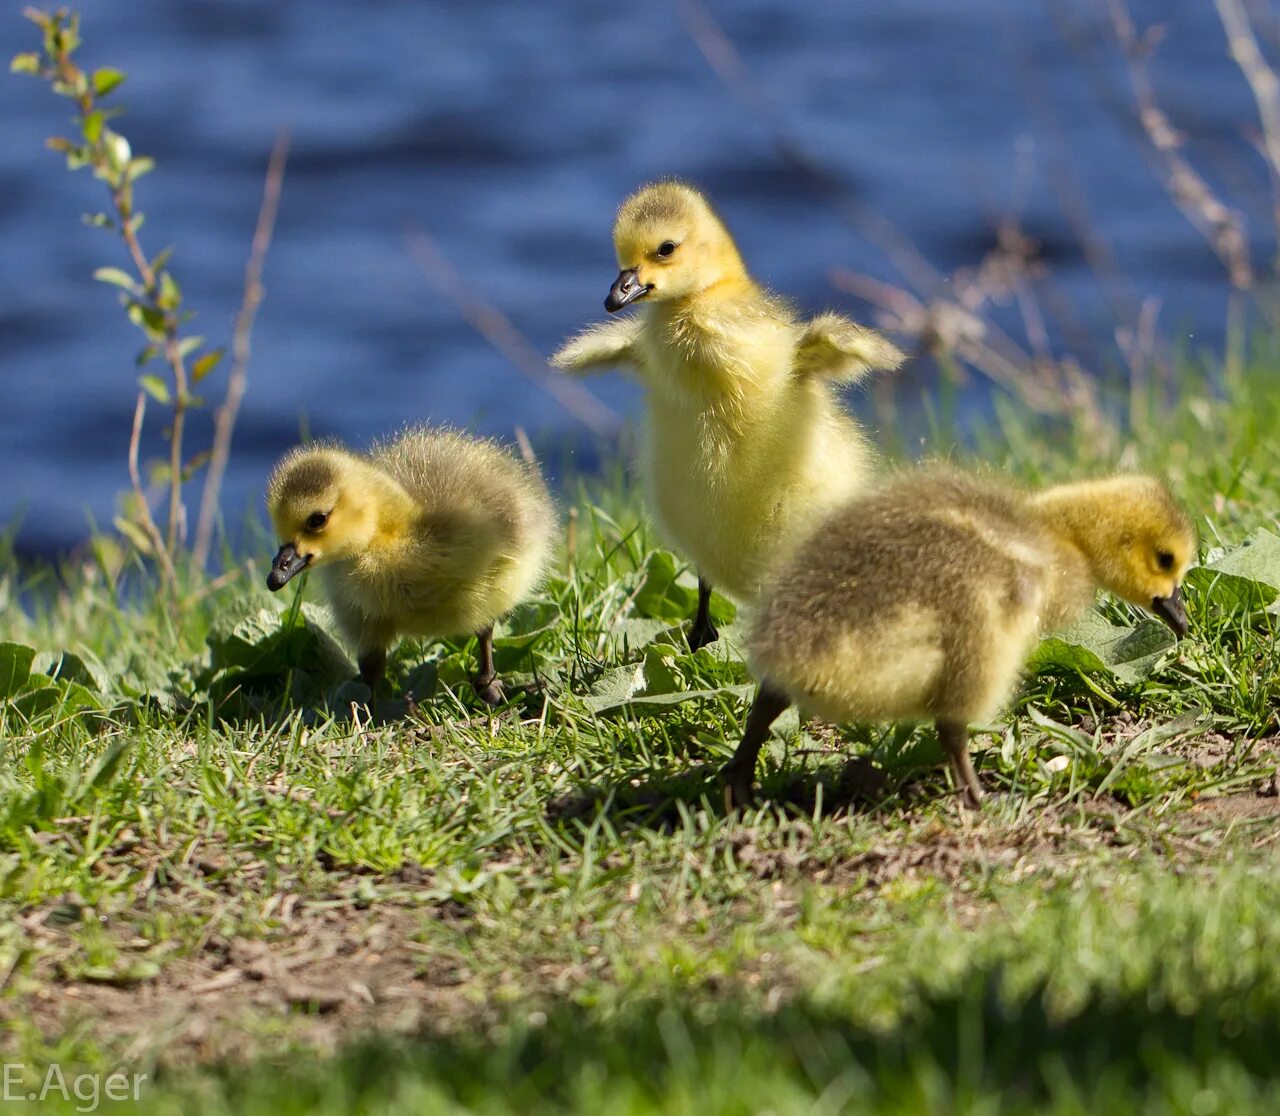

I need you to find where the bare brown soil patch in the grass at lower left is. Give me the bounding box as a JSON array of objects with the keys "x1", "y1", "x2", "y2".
[{"x1": 0, "y1": 904, "x2": 477, "y2": 1065}]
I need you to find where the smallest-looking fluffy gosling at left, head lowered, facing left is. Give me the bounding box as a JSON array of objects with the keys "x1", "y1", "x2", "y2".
[{"x1": 266, "y1": 427, "x2": 556, "y2": 705}]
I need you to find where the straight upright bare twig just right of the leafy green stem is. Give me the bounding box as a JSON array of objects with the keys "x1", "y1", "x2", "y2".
[{"x1": 192, "y1": 128, "x2": 289, "y2": 570}]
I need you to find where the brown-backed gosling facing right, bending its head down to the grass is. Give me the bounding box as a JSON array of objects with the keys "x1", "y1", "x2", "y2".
[{"x1": 723, "y1": 468, "x2": 1196, "y2": 806}]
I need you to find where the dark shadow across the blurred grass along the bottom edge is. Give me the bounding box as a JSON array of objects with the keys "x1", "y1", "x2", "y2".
[{"x1": 159, "y1": 969, "x2": 1280, "y2": 1113}]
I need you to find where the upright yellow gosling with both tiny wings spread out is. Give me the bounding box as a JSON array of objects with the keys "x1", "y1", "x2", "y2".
[{"x1": 552, "y1": 182, "x2": 902, "y2": 650}]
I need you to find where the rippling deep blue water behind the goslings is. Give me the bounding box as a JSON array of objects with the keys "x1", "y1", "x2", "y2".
[{"x1": 0, "y1": 0, "x2": 1259, "y2": 552}]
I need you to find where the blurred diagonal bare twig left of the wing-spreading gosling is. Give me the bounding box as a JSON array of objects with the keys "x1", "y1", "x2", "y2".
[{"x1": 404, "y1": 225, "x2": 620, "y2": 436}]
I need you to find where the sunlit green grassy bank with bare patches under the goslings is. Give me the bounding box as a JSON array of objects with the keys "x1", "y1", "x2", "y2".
[{"x1": 0, "y1": 358, "x2": 1280, "y2": 1113}]
